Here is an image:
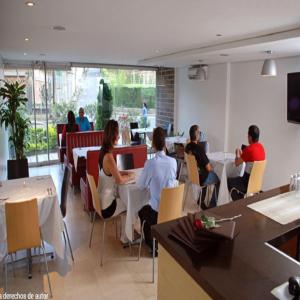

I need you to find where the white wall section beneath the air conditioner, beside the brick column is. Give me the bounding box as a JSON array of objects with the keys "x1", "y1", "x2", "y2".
[{"x1": 175, "y1": 64, "x2": 227, "y2": 151}]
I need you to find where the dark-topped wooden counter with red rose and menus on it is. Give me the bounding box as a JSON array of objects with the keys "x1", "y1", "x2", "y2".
[{"x1": 152, "y1": 186, "x2": 300, "y2": 300}]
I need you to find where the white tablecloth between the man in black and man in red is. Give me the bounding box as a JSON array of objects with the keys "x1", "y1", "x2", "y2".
[{"x1": 207, "y1": 152, "x2": 245, "y2": 206}]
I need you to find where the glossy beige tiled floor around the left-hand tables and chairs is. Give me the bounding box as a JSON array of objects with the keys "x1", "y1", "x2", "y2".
[{"x1": 0, "y1": 165, "x2": 157, "y2": 300}]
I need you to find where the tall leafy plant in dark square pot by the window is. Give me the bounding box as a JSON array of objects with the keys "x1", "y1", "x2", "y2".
[{"x1": 0, "y1": 80, "x2": 30, "y2": 179}]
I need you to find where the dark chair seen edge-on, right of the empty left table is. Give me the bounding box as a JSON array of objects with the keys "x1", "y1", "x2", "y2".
[{"x1": 60, "y1": 167, "x2": 74, "y2": 261}]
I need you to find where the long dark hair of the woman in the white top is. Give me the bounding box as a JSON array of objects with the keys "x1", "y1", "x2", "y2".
[{"x1": 99, "y1": 120, "x2": 119, "y2": 169}]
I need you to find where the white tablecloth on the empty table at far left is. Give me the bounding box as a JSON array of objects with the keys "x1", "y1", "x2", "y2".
[{"x1": 0, "y1": 176, "x2": 64, "y2": 261}]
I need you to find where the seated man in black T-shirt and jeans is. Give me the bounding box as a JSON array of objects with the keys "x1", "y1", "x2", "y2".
[{"x1": 185, "y1": 125, "x2": 220, "y2": 207}]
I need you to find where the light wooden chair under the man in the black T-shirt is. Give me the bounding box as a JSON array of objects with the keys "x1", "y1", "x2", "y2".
[{"x1": 184, "y1": 153, "x2": 217, "y2": 208}]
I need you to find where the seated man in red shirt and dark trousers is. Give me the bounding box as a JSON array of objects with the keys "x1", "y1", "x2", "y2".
[{"x1": 227, "y1": 125, "x2": 266, "y2": 200}]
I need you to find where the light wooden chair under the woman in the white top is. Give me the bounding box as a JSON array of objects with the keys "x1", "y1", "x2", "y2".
[{"x1": 86, "y1": 173, "x2": 123, "y2": 267}]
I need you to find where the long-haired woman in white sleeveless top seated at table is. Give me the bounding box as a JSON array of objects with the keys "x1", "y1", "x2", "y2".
[{"x1": 98, "y1": 120, "x2": 135, "y2": 218}]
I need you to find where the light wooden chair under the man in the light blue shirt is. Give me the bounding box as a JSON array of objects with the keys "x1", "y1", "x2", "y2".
[{"x1": 138, "y1": 184, "x2": 184, "y2": 282}]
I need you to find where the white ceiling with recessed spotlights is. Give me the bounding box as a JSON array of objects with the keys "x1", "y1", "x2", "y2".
[{"x1": 0, "y1": 0, "x2": 300, "y2": 66}]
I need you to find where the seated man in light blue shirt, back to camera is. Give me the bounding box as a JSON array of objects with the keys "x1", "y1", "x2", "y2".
[{"x1": 137, "y1": 127, "x2": 177, "y2": 251}]
